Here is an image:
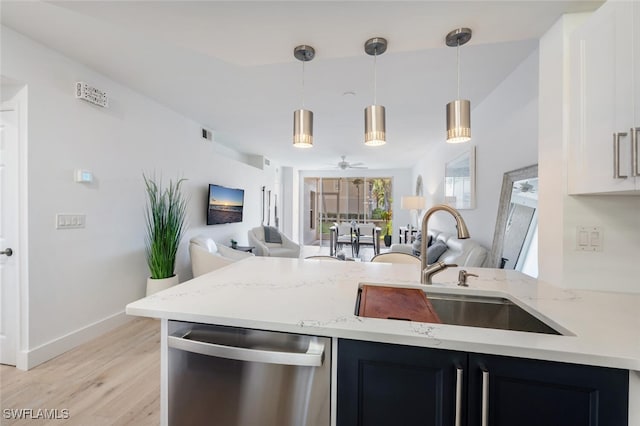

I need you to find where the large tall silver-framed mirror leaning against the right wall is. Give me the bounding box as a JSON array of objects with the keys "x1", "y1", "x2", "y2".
[{"x1": 488, "y1": 164, "x2": 538, "y2": 277}]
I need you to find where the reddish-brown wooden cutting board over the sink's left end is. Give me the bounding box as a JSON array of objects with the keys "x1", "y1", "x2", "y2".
[{"x1": 358, "y1": 285, "x2": 441, "y2": 323}]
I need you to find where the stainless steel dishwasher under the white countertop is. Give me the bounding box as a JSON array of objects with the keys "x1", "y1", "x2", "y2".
[{"x1": 167, "y1": 321, "x2": 331, "y2": 426}]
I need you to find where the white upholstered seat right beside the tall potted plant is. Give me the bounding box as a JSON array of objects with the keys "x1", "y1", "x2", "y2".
[{"x1": 189, "y1": 235, "x2": 253, "y2": 278}]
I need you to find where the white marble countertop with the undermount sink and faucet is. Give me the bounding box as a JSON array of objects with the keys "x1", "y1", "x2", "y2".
[{"x1": 126, "y1": 257, "x2": 640, "y2": 371}]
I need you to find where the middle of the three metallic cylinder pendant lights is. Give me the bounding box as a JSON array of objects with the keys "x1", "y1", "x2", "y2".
[{"x1": 364, "y1": 37, "x2": 387, "y2": 146}]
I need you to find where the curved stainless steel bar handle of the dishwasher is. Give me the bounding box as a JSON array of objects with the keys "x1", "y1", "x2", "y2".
[{"x1": 167, "y1": 333, "x2": 324, "y2": 367}]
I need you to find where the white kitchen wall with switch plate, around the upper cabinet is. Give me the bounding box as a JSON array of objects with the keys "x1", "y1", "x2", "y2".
[{"x1": 539, "y1": 14, "x2": 640, "y2": 293}]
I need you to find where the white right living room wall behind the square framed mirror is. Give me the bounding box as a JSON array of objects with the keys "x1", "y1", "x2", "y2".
[{"x1": 413, "y1": 50, "x2": 538, "y2": 250}]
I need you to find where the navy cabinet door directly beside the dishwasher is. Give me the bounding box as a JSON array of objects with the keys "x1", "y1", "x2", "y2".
[{"x1": 337, "y1": 340, "x2": 467, "y2": 426}]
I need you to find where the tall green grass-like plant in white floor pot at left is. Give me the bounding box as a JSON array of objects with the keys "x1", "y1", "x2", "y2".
[{"x1": 142, "y1": 174, "x2": 187, "y2": 279}]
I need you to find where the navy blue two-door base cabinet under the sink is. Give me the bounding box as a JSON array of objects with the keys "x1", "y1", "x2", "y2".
[{"x1": 337, "y1": 339, "x2": 629, "y2": 426}]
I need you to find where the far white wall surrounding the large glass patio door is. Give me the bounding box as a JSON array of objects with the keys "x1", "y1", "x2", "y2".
[{"x1": 297, "y1": 168, "x2": 415, "y2": 243}]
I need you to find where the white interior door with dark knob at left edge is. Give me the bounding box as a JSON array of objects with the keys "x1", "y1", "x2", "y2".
[{"x1": 0, "y1": 103, "x2": 19, "y2": 365}]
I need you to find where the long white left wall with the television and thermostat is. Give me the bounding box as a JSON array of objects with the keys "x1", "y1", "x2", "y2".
[{"x1": 1, "y1": 27, "x2": 276, "y2": 364}]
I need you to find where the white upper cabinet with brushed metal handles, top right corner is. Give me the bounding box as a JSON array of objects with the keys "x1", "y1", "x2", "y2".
[{"x1": 568, "y1": 1, "x2": 640, "y2": 194}]
